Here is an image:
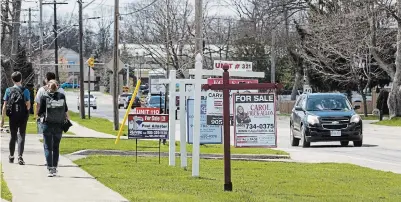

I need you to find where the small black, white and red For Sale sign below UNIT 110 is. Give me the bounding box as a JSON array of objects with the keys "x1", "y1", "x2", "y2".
[{"x1": 128, "y1": 114, "x2": 168, "y2": 139}]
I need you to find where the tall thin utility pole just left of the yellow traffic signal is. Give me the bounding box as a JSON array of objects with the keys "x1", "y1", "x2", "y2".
[{"x1": 78, "y1": 0, "x2": 85, "y2": 119}]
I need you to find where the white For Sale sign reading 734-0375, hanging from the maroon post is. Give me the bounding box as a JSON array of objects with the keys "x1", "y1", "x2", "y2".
[{"x1": 233, "y1": 93, "x2": 277, "y2": 147}]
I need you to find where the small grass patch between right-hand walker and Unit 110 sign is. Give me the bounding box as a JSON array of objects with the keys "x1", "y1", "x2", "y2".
[{"x1": 68, "y1": 111, "x2": 128, "y2": 136}]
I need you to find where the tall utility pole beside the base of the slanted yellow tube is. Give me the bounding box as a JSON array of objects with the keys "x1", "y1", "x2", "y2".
[{"x1": 113, "y1": 0, "x2": 120, "y2": 130}]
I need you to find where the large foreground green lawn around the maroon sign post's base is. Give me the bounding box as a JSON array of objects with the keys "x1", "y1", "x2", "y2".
[{"x1": 75, "y1": 156, "x2": 401, "y2": 202}]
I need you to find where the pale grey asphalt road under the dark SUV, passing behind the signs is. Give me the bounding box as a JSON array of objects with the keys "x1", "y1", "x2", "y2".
[{"x1": 67, "y1": 92, "x2": 401, "y2": 174}]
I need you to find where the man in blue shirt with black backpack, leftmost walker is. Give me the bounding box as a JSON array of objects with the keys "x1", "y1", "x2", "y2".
[{"x1": 1, "y1": 71, "x2": 31, "y2": 165}]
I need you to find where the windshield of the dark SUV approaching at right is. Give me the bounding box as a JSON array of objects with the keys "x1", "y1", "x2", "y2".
[{"x1": 307, "y1": 97, "x2": 352, "y2": 111}]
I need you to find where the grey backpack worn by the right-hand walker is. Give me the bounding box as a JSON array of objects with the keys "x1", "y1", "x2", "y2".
[{"x1": 44, "y1": 92, "x2": 66, "y2": 124}]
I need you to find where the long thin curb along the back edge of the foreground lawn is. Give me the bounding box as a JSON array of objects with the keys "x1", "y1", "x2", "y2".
[{"x1": 69, "y1": 149, "x2": 290, "y2": 161}]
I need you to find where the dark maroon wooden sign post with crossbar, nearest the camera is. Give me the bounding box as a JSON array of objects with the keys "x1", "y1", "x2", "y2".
[{"x1": 202, "y1": 64, "x2": 281, "y2": 191}]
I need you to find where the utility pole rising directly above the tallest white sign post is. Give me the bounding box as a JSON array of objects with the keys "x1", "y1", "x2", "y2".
[{"x1": 195, "y1": 0, "x2": 203, "y2": 55}]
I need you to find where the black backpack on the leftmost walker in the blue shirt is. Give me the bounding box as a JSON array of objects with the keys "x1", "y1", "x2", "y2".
[{"x1": 6, "y1": 87, "x2": 28, "y2": 120}]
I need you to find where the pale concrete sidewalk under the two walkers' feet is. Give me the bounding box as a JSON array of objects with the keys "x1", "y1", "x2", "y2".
[{"x1": 1, "y1": 133, "x2": 128, "y2": 202}]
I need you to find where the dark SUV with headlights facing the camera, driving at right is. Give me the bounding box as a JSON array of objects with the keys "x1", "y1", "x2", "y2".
[{"x1": 290, "y1": 93, "x2": 363, "y2": 147}]
